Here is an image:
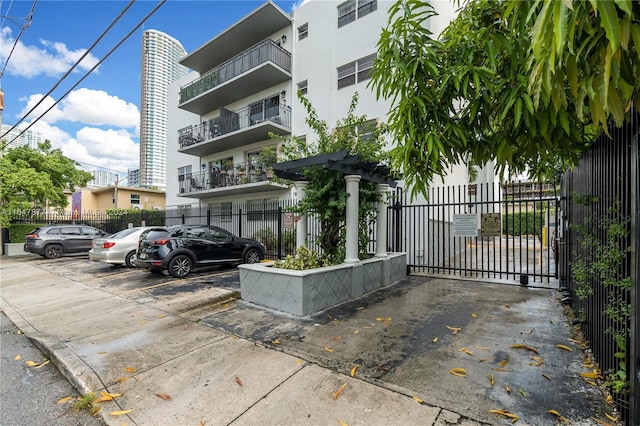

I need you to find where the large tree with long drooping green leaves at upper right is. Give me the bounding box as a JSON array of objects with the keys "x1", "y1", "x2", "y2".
[{"x1": 370, "y1": 0, "x2": 640, "y2": 198}]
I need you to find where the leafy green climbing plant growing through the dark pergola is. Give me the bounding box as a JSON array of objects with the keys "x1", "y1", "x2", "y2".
[{"x1": 282, "y1": 93, "x2": 387, "y2": 264}]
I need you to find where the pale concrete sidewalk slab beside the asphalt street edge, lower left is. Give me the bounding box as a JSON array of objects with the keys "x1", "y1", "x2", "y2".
[{"x1": 103, "y1": 337, "x2": 303, "y2": 426}]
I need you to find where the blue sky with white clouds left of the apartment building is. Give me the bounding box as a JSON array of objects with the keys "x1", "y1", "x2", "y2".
[{"x1": 0, "y1": 0, "x2": 300, "y2": 176}]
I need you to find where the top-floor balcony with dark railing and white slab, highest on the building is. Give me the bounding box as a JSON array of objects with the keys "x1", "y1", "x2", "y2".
[{"x1": 178, "y1": 39, "x2": 291, "y2": 115}]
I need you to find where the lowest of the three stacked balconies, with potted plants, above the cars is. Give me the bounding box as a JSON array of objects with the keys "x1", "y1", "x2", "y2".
[{"x1": 178, "y1": 162, "x2": 287, "y2": 198}]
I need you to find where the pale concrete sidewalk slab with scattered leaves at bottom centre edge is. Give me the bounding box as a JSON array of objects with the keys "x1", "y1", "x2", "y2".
[{"x1": 232, "y1": 365, "x2": 440, "y2": 426}]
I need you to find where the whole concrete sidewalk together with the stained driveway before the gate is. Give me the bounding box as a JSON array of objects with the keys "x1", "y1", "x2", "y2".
[{"x1": 0, "y1": 258, "x2": 608, "y2": 425}]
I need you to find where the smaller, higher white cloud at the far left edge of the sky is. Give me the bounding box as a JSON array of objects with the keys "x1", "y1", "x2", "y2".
[{"x1": 0, "y1": 27, "x2": 99, "y2": 79}]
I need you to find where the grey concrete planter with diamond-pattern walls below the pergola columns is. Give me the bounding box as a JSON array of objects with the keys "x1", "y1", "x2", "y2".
[{"x1": 239, "y1": 253, "x2": 407, "y2": 316}]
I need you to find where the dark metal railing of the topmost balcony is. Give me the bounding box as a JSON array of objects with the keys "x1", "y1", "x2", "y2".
[{"x1": 180, "y1": 39, "x2": 291, "y2": 103}]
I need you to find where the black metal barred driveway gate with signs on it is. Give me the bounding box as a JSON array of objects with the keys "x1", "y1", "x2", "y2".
[{"x1": 388, "y1": 182, "x2": 558, "y2": 287}]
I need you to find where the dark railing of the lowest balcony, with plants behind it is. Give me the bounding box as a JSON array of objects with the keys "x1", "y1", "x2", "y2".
[{"x1": 178, "y1": 162, "x2": 273, "y2": 193}]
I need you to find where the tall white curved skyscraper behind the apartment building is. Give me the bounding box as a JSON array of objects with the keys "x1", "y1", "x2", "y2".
[{"x1": 140, "y1": 30, "x2": 189, "y2": 190}]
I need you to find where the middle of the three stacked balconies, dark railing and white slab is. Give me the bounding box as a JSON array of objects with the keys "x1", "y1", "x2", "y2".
[{"x1": 178, "y1": 104, "x2": 291, "y2": 157}]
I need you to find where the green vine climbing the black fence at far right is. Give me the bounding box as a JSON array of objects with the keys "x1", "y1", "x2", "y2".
[{"x1": 571, "y1": 201, "x2": 632, "y2": 392}]
